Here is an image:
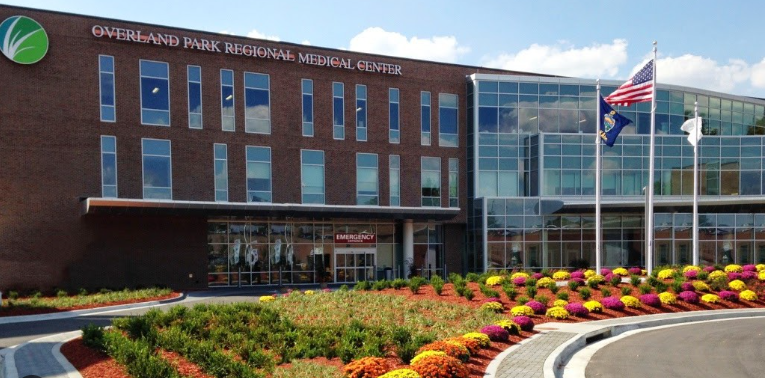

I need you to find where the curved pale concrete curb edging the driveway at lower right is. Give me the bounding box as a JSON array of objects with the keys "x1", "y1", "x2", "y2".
[{"x1": 544, "y1": 308, "x2": 765, "y2": 378}]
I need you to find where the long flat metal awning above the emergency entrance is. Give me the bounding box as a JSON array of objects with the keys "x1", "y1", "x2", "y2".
[{"x1": 82, "y1": 198, "x2": 460, "y2": 221}]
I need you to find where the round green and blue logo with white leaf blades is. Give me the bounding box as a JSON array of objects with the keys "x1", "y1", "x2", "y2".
[{"x1": 0, "y1": 16, "x2": 48, "y2": 64}]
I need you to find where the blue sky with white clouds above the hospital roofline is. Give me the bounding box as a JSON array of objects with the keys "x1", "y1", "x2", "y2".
[{"x1": 5, "y1": 0, "x2": 765, "y2": 98}]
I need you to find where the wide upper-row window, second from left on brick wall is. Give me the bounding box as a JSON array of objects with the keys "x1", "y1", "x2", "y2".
[{"x1": 141, "y1": 60, "x2": 170, "y2": 126}]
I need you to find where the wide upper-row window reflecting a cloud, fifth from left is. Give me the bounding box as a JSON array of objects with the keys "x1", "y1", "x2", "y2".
[{"x1": 244, "y1": 72, "x2": 271, "y2": 134}]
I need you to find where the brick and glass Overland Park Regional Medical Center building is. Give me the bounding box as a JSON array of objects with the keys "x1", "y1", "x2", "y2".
[{"x1": 0, "y1": 6, "x2": 765, "y2": 288}]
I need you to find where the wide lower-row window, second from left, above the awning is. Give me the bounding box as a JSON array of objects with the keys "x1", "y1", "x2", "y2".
[{"x1": 141, "y1": 139, "x2": 173, "y2": 199}]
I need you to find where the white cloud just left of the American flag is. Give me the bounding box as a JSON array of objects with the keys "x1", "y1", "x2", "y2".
[{"x1": 484, "y1": 39, "x2": 627, "y2": 78}]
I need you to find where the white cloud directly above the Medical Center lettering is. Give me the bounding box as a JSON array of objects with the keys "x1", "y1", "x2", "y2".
[{"x1": 348, "y1": 27, "x2": 470, "y2": 63}]
